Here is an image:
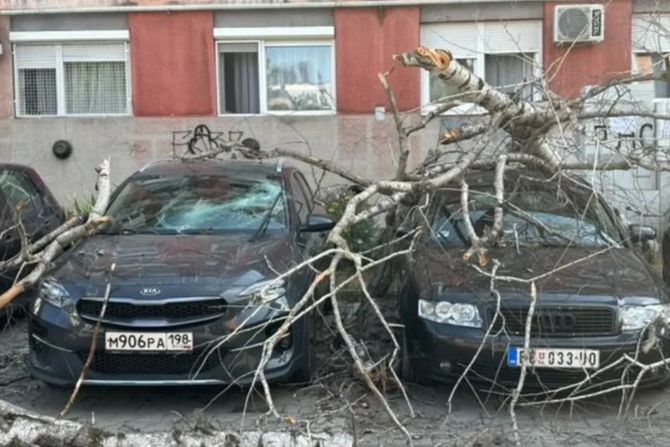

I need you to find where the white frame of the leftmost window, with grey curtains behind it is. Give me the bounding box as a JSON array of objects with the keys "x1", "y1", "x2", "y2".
[{"x1": 12, "y1": 39, "x2": 133, "y2": 119}]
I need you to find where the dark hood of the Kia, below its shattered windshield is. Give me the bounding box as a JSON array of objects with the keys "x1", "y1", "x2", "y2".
[{"x1": 53, "y1": 234, "x2": 296, "y2": 298}]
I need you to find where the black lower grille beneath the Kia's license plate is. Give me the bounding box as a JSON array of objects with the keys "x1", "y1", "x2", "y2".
[{"x1": 79, "y1": 352, "x2": 219, "y2": 377}]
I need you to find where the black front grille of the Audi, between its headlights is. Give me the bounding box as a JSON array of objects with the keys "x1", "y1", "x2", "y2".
[{"x1": 488, "y1": 306, "x2": 616, "y2": 337}]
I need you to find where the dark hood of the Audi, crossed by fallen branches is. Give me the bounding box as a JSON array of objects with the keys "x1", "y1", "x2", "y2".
[{"x1": 417, "y1": 245, "x2": 664, "y2": 298}]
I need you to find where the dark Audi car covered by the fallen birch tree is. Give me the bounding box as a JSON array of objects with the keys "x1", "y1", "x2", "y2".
[{"x1": 400, "y1": 170, "x2": 670, "y2": 389}]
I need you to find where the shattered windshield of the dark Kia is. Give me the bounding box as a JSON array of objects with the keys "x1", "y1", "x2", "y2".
[{"x1": 107, "y1": 175, "x2": 286, "y2": 234}]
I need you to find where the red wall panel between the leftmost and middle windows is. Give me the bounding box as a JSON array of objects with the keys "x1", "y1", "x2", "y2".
[{"x1": 128, "y1": 11, "x2": 217, "y2": 116}]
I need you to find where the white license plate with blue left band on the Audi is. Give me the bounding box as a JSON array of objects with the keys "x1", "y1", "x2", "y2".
[{"x1": 507, "y1": 347, "x2": 600, "y2": 369}]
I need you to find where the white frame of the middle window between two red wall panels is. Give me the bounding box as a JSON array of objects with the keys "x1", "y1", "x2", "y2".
[{"x1": 214, "y1": 36, "x2": 337, "y2": 118}]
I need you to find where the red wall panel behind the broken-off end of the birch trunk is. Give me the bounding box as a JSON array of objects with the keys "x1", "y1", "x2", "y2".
[{"x1": 335, "y1": 7, "x2": 420, "y2": 113}]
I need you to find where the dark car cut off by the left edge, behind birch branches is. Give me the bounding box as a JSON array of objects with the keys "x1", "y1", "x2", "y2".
[{"x1": 0, "y1": 164, "x2": 65, "y2": 293}]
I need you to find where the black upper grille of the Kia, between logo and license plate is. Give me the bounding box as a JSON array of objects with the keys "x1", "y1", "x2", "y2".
[{"x1": 77, "y1": 297, "x2": 226, "y2": 327}]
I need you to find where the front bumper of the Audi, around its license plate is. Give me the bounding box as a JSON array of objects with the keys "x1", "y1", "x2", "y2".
[{"x1": 408, "y1": 321, "x2": 670, "y2": 389}]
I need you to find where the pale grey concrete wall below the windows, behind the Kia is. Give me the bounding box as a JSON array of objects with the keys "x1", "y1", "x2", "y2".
[{"x1": 0, "y1": 114, "x2": 437, "y2": 205}]
